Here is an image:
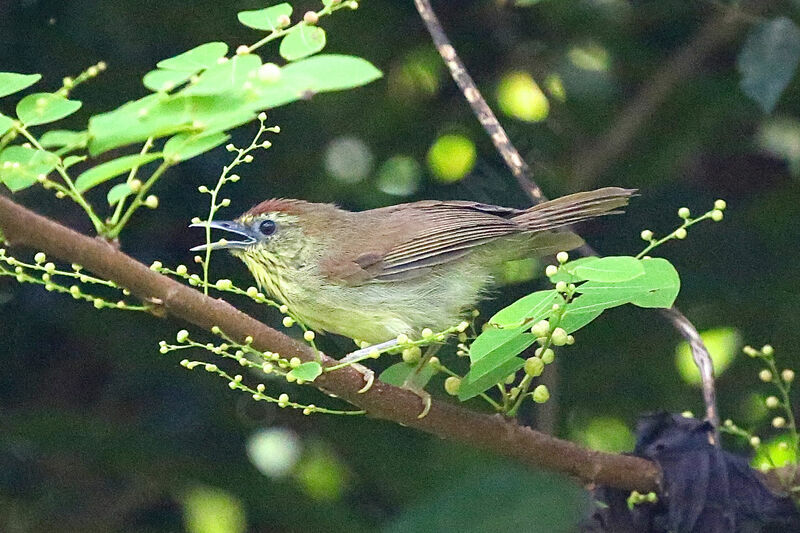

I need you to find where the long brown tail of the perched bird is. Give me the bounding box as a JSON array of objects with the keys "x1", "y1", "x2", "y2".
[{"x1": 511, "y1": 187, "x2": 636, "y2": 231}]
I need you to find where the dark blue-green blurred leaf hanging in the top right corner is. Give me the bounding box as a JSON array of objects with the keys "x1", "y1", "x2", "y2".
[{"x1": 736, "y1": 17, "x2": 800, "y2": 113}]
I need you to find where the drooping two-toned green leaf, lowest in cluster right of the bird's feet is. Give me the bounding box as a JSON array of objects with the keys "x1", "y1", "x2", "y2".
[{"x1": 458, "y1": 328, "x2": 536, "y2": 401}]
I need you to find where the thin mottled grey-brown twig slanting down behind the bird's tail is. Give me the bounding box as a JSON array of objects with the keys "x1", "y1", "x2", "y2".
[{"x1": 414, "y1": 0, "x2": 720, "y2": 440}]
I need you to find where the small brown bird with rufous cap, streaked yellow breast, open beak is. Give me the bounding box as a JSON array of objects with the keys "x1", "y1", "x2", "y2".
[{"x1": 192, "y1": 187, "x2": 636, "y2": 344}]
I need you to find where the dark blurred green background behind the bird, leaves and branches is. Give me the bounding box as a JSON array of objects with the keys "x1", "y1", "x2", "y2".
[{"x1": 0, "y1": 0, "x2": 800, "y2": 532}]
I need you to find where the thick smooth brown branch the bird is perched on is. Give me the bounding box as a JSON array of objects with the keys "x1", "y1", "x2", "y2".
[{"x1": 0, "y1": 196, "x2": 659, "y2": 491}]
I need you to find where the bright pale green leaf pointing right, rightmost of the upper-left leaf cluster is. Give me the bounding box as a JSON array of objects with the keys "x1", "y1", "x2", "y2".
[{"x1": 281, "y1": 54, "x2": 383, "y2": 93}]
